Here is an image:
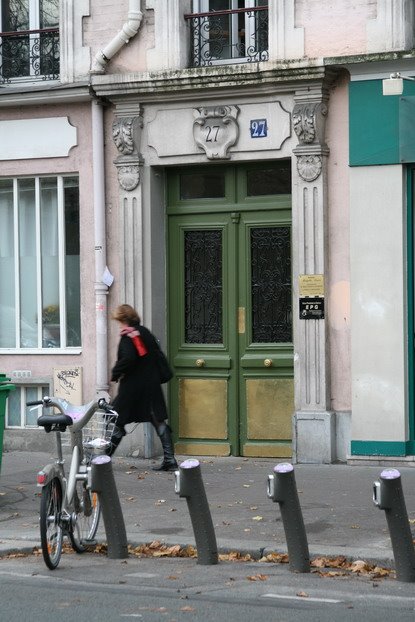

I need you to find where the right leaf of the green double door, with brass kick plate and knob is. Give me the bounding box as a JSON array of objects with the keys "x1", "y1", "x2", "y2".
[{"x1": 238, "y1": 211, "x2": 294, "y2": 456}]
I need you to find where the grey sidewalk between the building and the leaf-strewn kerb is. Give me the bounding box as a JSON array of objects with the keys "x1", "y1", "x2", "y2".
[{"x1": 0, "y1": 451, "x2": 415, "y2": 568}]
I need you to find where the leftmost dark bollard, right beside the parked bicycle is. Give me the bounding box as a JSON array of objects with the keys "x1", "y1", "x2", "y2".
[{"x1": 91, "y1": 456, "x2": 128, "y2": 559}]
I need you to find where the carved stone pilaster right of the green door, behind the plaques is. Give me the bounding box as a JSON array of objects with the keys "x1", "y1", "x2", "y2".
[{"x1": 292, "y1": 84, "x2": 336, "y2": 463}]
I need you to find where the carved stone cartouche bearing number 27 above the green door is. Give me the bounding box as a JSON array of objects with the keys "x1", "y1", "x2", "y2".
[{"x1": 193, "y1": 106, "x2": 239, "y2": 160}]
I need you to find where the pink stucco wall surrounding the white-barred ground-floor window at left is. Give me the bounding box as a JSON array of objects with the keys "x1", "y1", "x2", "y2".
[{"x1": 0, "y1": 103, "x2": 95, "y2": 400}]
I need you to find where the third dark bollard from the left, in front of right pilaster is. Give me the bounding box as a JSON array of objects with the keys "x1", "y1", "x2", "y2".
[{"x1": 267, "y1": 463, "x2": 310, "y2": 572}]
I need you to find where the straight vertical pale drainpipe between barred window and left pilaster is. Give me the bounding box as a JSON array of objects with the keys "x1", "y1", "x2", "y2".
[{"x1": 91, "y1": 99, "x2": 108, "y2": 395}]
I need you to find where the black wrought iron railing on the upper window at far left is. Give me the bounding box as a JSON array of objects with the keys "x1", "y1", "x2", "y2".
[{"x1": 0, "y1": 28, "x2": 59, "y2": 83}]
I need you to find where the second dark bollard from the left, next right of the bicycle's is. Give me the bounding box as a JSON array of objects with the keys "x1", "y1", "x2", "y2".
[{"x1": 174, "y1": 460, "x2": 219, "y2": 566}]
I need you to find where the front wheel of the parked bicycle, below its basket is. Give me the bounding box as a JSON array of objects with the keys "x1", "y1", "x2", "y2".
[{"x1": 69, "y1": 481, "x2": 101, "y2": 553}]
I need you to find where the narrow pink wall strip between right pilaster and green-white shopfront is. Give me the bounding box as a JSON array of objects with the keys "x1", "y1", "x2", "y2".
[{"x1": 326, "y1": 73, "x2": 351, "y2": 411}]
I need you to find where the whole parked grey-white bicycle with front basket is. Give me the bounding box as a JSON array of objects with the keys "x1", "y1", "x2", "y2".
[{"x1": 27, "y1": 396, "x2": 118, "y2": 570}]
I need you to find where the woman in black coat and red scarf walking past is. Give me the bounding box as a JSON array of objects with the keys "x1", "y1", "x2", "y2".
[{"x1": 109, "y1": 304, "x2": 178, "y2": 471}]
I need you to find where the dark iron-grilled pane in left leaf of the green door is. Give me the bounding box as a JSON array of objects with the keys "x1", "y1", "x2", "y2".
[{"x1": 184, "y1": 230, "x2": 222, "y2": 343}]
